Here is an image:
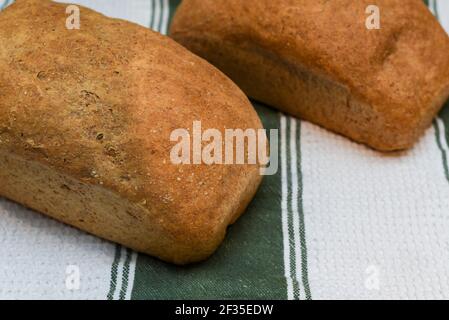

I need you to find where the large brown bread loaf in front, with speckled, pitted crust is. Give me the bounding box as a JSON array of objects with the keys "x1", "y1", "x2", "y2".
[{"x1": 0, "y1": 0, "x2": 262, "y2": 264}]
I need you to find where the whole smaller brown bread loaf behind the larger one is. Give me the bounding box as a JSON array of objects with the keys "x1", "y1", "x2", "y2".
[{"x1": 171, "y1": 0, "x2": 449, "y2": 151}]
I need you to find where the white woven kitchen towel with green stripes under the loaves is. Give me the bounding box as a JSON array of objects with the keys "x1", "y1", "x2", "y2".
[{"x1": 0, "y1": 0, "x2": 449, "y2": 300}]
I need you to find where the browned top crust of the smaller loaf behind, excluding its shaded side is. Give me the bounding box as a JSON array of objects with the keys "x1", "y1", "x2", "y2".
[{"x1": 171, "y1": 0, "x2": 449, "y2": 149}]
